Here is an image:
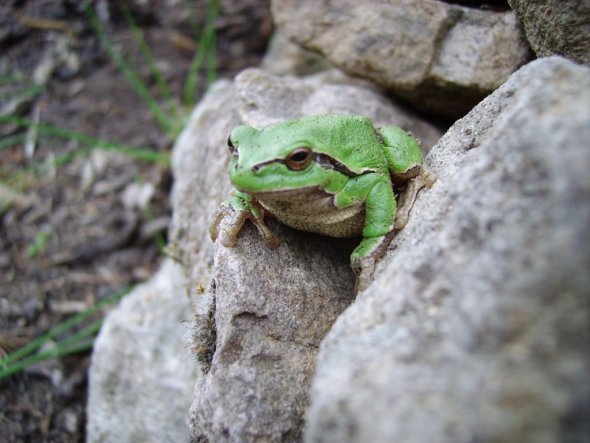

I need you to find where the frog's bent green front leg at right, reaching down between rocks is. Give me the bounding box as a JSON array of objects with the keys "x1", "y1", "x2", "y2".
[{"x1": 336, "y1": 174, "x2": 396, "y2": 290}]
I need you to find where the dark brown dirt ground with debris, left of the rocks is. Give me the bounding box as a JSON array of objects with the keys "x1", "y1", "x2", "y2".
[{"x1": 0, "y1": 0, "x2": 272, "y2": 442}]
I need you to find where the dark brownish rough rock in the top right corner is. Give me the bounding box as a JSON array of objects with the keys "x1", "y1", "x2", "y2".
[{"x1": 508, "y1": 0, "x2": 590, "y2": 65}]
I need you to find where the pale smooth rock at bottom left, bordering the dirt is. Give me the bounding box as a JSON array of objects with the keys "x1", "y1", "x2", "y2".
[{"x1": 87, "y1": 260, "x2": 196, "y2": 443}]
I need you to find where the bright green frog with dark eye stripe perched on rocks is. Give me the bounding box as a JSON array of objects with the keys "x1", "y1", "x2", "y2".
[{"x1": 209, "y1": 115, "x2": 436, "y2": 292}]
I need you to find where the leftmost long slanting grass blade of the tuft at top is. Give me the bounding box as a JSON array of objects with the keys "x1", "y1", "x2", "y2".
[{"x1": 84, "y1": 2, "x2": 178, "y2": 140}]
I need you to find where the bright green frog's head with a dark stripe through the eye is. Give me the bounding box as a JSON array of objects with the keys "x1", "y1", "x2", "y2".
[{"x1": 227, "y1": 121, "x2": 346, "y2": 194}]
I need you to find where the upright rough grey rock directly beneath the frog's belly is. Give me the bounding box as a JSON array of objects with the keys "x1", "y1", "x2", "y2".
[{"x1": 191, "y1": 225, "x2": 354, "y2": 442}]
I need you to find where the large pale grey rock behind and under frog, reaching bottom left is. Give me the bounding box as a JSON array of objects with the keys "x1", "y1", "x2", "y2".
[{"x1": 88, "y1": 64, "x2": 441, "y2": 443}]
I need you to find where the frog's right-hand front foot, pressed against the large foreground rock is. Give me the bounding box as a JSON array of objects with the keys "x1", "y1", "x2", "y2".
[{"x1": 350, "y1": 229, "x2": 397, "y2": 293}]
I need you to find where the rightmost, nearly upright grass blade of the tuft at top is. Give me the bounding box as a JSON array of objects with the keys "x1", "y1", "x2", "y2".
[{"x1": 183, "y1": 0, "x2": 219, "y2": 108}]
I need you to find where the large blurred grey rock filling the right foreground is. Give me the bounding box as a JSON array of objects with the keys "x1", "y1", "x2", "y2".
[{"x1": 305, "y1": 57, "x2": 590, "y2": 443}]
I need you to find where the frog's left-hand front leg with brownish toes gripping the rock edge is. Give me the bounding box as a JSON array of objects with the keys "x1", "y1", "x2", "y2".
[{"x1": 209, "y1": 191, "x2": 280, "y2": 249}]
